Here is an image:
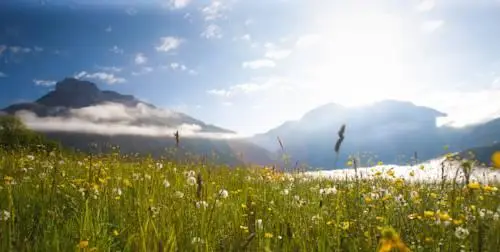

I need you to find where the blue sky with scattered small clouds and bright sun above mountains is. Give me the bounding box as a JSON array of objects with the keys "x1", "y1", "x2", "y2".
[{"x1": 0, "y1": 0, "x2": 500, "y2": 135}]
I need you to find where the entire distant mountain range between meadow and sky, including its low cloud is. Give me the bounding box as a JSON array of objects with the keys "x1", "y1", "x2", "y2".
[{"x1": 0, "y1": 78, "x2": 500, "y2": 169}]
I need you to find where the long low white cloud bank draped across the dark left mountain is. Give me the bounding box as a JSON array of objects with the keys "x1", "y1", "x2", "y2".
[{"x1": 16, "y1": 103, "x2": 236, "y2": 139}]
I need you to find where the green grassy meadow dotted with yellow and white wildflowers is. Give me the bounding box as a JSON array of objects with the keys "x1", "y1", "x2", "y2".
[{"x1": 0, "y1": 147, "x2": 500, "y2": 251}]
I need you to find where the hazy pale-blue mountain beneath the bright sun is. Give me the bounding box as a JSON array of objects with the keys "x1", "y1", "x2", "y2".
[{"x1": 251, "y1": 100, "x2": 500, "y2": 169}]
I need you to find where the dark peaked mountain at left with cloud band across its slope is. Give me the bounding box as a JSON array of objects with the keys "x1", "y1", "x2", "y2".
[{"x1": 0, "y1": 78, "x2": 272, "y2": 165}]
